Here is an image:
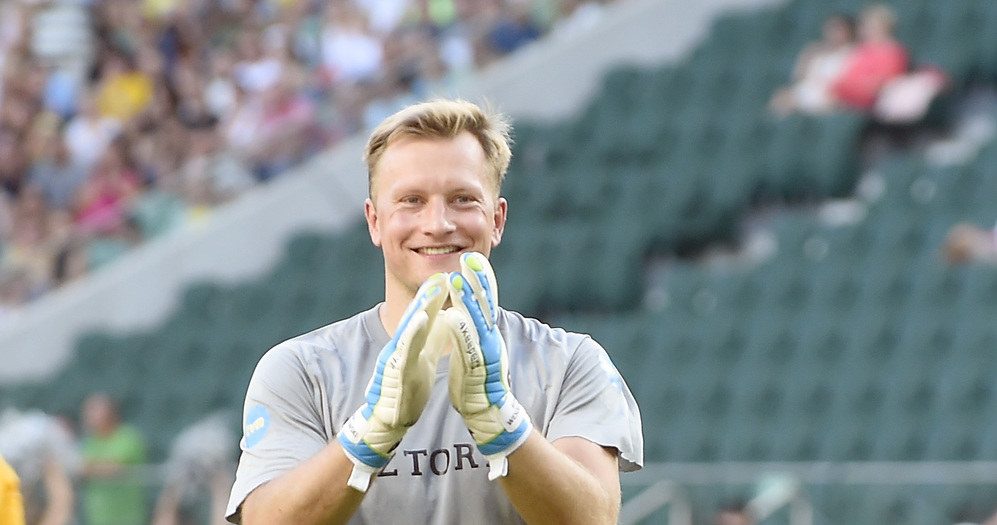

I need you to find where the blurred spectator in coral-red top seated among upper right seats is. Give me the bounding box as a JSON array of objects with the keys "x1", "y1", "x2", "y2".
[{"x1": 832, "y1": 5, "x2": 907, "y2": 110}]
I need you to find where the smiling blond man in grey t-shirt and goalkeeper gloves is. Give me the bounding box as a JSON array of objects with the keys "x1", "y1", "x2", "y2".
[{"x1": 227, "y1": 101, "x2": 643, "y2": 525}]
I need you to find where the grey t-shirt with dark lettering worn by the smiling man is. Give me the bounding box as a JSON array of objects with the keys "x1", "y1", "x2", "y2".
[{"x1": 226, "y1": 306, "x2": 644, "y2": 524}]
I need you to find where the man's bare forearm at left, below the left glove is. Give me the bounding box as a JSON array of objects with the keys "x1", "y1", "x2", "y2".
[{"x1": 242, "y1": 441, "x2": 364, "y2": 525}]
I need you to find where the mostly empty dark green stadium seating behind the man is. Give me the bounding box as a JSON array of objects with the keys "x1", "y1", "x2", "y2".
[{"x1": 0, "y1": 0, "x2": 997, "y2": 524}]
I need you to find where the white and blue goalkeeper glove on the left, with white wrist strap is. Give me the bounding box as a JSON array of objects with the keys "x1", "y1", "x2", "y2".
[{"x1": 336, "y1": 273, "x2": 447, "y2": 492}]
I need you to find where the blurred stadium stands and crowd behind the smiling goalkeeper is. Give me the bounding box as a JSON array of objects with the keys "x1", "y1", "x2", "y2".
[{"x1": 0, "y1": 0, "x2": 997, "y2": 525}]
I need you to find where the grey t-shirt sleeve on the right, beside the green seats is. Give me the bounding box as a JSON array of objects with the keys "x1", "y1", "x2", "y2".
[{"x1": 546, "y1": 337, "x2": 644, "y2": 472}]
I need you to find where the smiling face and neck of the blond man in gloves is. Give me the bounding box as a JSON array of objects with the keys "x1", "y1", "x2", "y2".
[{"x1": 364, "y1": 132, "x2": 507, "y2": 303}]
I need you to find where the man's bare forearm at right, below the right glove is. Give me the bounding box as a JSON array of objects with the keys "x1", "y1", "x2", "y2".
[{"x1": 499, "y1": 431, "x2": 620, "y2": 524}]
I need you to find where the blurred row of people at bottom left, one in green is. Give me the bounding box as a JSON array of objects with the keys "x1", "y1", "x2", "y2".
[{"x1": 0, "y1": 392, "x2": 238, "y2": 525}]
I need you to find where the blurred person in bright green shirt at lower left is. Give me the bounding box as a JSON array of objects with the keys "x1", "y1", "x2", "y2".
[{"x1": 82, "y1": 393, "x2": 147, "y2": 525}]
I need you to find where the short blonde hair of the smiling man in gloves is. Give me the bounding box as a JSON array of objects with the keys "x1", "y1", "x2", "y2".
[{"x1": 363, "y1": 99, "x2": 512, "y2": 197}]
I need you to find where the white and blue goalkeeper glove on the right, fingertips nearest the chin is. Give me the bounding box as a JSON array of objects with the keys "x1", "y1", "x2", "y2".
[{"x1": 444, "y1": 252, "x2": 533, "y2": 480}]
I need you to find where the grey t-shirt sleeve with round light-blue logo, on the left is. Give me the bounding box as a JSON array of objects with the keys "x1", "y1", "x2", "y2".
[{"x1": 225, "y1": 346, "x2": 330, "y2": 523}]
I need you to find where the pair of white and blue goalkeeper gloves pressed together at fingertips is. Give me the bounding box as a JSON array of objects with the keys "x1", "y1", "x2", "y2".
[{"x1": 337, "y1": 252, "x2": 533, "y2": 492}]
